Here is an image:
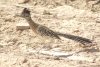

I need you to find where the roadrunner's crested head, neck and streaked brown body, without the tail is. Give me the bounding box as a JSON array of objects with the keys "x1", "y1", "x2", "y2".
[{"x1": 21, "y1": 8, "x2": 60, "y2": 39}]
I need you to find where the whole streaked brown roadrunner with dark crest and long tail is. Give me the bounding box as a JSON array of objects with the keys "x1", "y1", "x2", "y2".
[{"x1": 20, "y1": 8, "x2": 92, "y2": 45}]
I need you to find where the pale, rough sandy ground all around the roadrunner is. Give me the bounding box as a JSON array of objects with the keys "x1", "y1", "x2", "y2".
[{"x1": 0, "y1": 0, "x2": 100, "y2": 67}]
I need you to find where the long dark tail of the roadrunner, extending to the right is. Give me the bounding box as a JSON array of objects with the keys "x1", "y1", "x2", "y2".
[{"x1": 57, "y1": 33, "x2": 92, "y2": 45}]
